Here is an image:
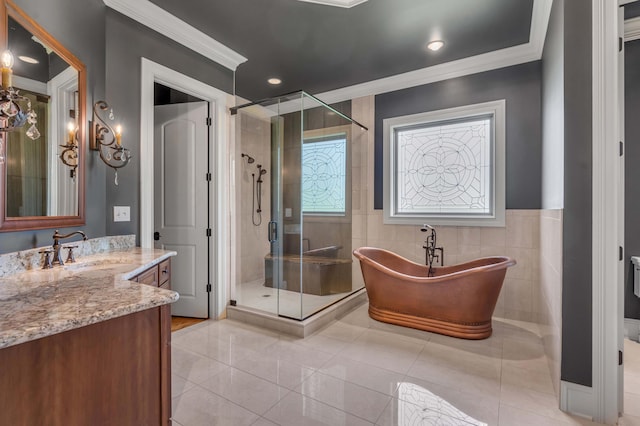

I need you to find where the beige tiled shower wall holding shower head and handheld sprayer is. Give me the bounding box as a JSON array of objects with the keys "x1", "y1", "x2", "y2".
[{"x1": 236, "y1": 111, "x2": 272, "y2": 283}]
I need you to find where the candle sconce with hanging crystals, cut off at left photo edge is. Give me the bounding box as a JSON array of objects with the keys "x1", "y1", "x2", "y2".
[{"x1": 0, "y1": 50, "x2": 40, "y2": 140}]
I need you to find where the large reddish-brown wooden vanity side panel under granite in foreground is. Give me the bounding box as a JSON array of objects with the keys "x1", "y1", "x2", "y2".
[{"x1": 0, "y1": 305, "x2": 171, "y2": 426}]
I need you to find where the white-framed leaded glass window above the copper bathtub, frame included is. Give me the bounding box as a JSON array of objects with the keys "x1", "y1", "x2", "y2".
[{"x1": 383, "y1": 100, "x2": 506, "y2": 226}]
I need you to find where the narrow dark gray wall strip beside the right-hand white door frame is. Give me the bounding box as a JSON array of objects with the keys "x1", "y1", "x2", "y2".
[{"x1": 561, "y1": 0, "x2": 592, "y2": 386}]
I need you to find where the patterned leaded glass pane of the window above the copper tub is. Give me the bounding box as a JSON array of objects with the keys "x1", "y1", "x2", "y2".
[{"x1": 395, "y1": 116, "x2": 493, "y2": 215}]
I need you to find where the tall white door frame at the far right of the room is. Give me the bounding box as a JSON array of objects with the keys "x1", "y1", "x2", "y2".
[{"x1": 591, "y1": 0, "x2": 624, "y2": 424}]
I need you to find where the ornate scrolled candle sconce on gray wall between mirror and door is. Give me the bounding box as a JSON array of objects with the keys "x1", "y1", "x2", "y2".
[{"x1": 89, "y1": 101, "x2": 131, "y2": 185}]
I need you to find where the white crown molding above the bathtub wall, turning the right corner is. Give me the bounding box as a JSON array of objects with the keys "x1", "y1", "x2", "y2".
[{"x1": 315, "y1": 0, "x2": 553, "y2": 104}]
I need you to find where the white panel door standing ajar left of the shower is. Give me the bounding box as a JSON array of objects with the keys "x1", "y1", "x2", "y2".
[{"x1": 154, "y1": 102, "x2": 209, "y2": 318}]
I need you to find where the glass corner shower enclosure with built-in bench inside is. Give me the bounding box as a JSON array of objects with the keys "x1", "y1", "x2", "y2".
[{"x1": 232, "y1": 92, "x2": 366, "y2": 320}]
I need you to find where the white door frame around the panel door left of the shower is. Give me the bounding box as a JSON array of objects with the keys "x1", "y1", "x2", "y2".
[{"x1": 140, "y1": 58, "x2": 233, "y2": 318}]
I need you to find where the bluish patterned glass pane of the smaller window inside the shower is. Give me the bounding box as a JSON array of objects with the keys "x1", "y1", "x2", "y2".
[{"x1": 302, "y1": 135, "x2": 347, "y2": 214}]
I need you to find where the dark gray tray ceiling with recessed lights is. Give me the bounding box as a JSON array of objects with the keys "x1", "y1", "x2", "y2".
[{"x1": 151, "y1": 0, "x2": 533, "y2": 100}]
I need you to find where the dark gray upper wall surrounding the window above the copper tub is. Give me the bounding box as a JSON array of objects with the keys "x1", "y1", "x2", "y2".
[{"x1": 374, "y1": 61, "x2": 542, "y2": 209}]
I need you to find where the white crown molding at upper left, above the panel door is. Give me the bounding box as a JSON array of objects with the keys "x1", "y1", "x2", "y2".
[{"x1": 103, "y1": 0, "x2": 247, "y2": 71}]
